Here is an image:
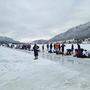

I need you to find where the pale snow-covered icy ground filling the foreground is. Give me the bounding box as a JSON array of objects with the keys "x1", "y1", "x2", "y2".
[{"x1": 0, "y1": 47, "x2": 90, "y2": 90}]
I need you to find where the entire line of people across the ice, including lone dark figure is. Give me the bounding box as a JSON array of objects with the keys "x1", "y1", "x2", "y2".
[{"x1": 2, "y1": 43, "x2": 90, "y2": 60}]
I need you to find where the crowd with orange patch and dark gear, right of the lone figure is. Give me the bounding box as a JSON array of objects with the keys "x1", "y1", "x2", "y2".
[{"x1": 44, "y1": 43, "x2": 90, "y2": 58}]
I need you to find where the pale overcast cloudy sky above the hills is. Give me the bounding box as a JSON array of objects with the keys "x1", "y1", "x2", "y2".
[{"x1": 0, "y1": 0, "x2": 90, "y2": 42}]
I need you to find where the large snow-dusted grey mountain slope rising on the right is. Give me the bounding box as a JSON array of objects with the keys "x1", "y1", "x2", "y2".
[{"x1": 50, "y1": 22, "x2": 90, "y2": 41}]
